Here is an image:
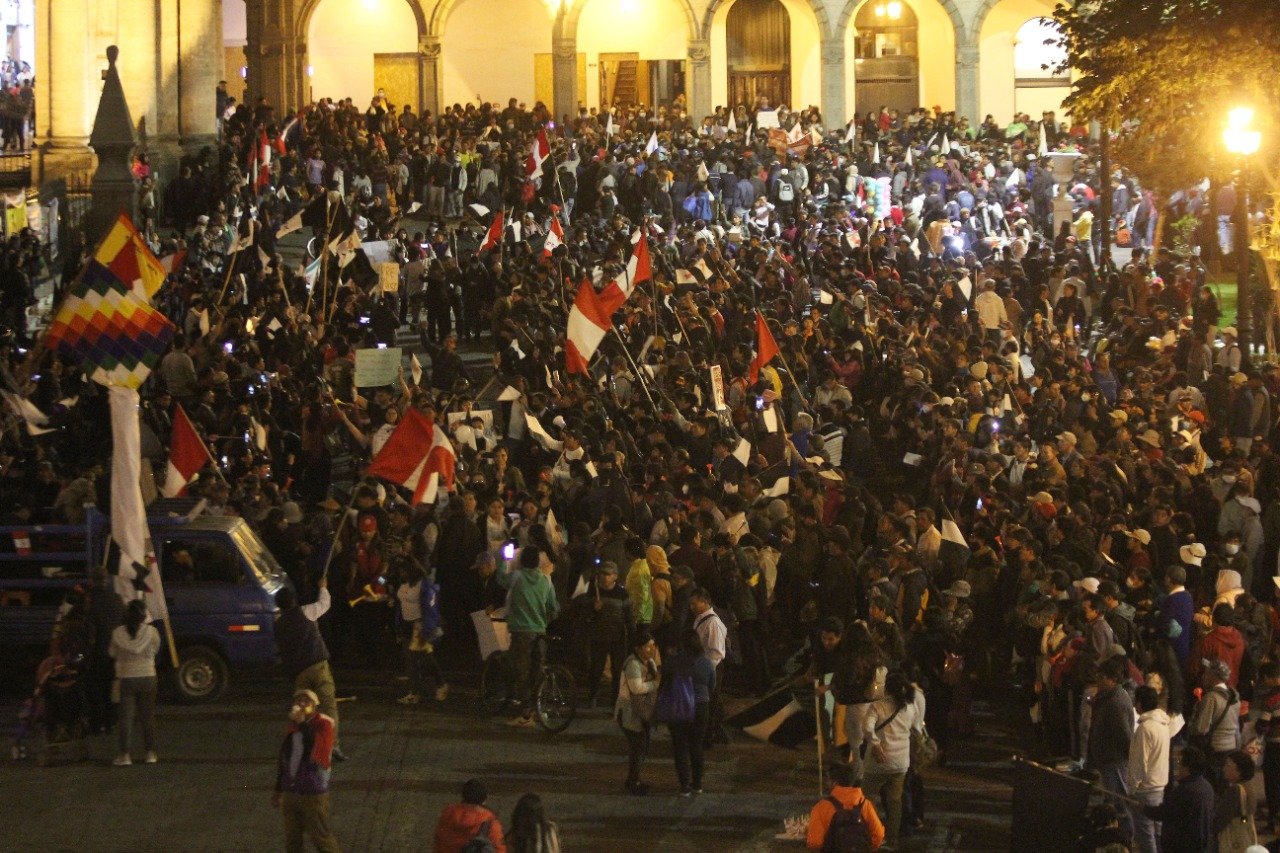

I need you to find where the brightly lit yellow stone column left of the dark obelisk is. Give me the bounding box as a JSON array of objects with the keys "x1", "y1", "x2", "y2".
[{"x1": 33, "y1": 0, "x2": 100, "y2": 184}]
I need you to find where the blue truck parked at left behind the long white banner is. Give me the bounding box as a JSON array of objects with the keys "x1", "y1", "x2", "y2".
[{"x1": 0, "y1": 510, "x2": 289, "y2": 703}]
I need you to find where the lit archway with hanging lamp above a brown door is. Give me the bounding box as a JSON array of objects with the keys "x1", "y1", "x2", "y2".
[{"x1": 845, "y1": 0, "x2": 956, "y2": 122}]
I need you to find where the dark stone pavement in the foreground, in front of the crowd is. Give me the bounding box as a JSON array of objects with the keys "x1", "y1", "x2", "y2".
[{"x1": 0, "y1": 674, "x2": 1010, "y2": 853}]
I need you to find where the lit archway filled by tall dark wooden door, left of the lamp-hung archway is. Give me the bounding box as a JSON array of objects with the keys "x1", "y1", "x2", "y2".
[{"x1": 707, "y1": 0, "x2": 826, "y2": 109}]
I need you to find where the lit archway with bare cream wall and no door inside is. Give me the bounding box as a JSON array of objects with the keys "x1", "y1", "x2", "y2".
[{"x1": 433, "y1": 0, "x2": 552, "y2": 106}]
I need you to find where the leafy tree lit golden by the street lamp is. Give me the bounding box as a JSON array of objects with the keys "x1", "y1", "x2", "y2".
[{"x1": 1053, "y1": 0, "x2": 1280, "y2": 191}]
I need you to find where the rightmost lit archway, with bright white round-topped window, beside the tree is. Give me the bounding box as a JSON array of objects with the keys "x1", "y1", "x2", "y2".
[{"x1": 974, "y1": 0, "x2": 1071, "y2": 126}]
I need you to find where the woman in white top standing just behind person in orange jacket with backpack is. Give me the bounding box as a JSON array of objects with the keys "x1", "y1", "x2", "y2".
[{"x1": 863, "y1": 670, "x2": 924, "y2": 848}]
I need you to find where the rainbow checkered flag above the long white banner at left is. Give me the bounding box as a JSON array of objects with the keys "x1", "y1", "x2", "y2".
[{"x1": 46, "y1": 214, "x2": 175, "y2": 389}]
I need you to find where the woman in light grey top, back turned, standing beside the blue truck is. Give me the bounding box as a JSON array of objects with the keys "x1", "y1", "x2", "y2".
[{"x1": 109, "y1": 598, "x2": 160, "y2": 767}]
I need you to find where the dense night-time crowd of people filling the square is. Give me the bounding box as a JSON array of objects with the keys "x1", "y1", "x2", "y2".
[{"x1": 12, "y1": 79, "x2": 1280, "y2": 850}]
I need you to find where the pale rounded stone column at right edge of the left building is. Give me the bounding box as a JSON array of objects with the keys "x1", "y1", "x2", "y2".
[{"x1": 178, "y1": 0, "x2": 223, "y2": 151}]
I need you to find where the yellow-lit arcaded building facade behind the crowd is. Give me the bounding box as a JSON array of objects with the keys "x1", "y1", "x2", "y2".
[{"x1": 238, "y1": 0, "x2": 1069, "y2": 126}]
